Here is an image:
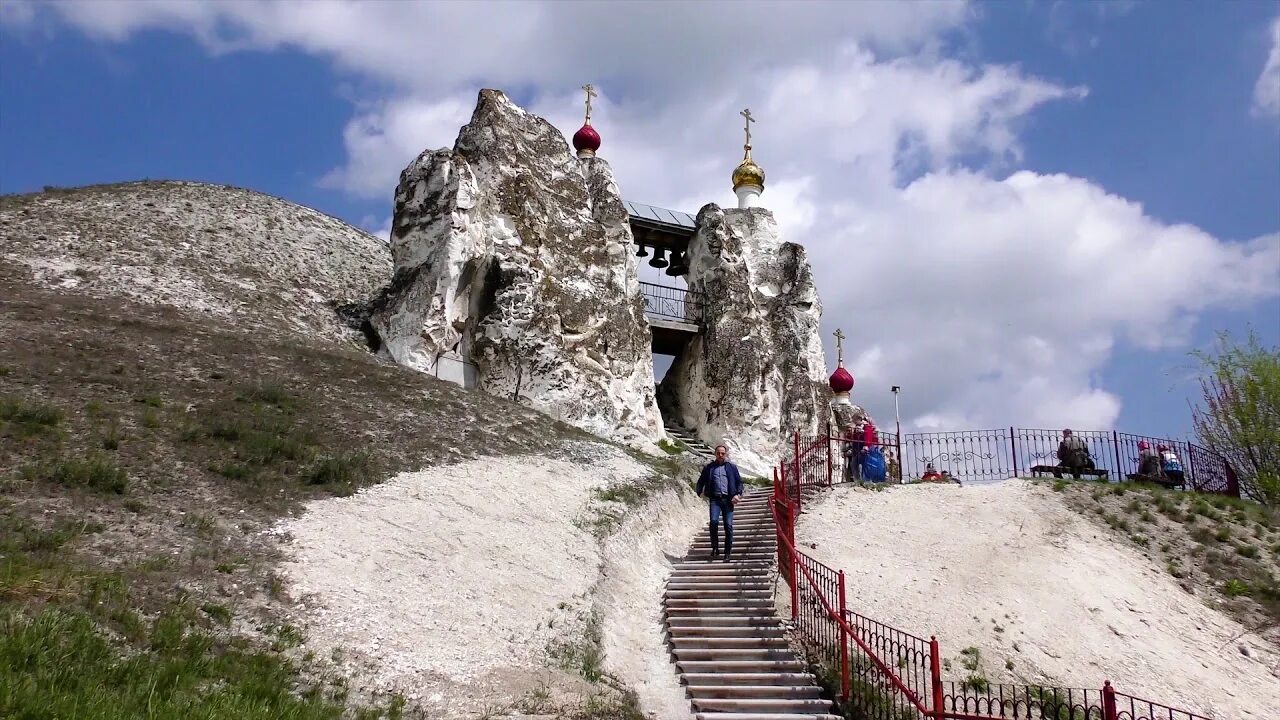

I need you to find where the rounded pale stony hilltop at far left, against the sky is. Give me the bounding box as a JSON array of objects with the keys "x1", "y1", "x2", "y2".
[{"x1": 0, "y1": 181, "x2": 392, "y2": 346}]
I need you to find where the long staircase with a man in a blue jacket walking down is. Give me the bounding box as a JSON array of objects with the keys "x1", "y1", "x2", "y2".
[{"x1": 663, "y1": 484, "x2": 841, "y2": 720}]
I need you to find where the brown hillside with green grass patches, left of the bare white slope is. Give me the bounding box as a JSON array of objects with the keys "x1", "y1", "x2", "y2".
[{"x1": 0, "y1": 269, "x2": 609, "y2": 719}]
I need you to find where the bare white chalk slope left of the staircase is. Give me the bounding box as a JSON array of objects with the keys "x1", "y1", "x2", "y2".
[{"x1": 278, "y1": 443, "x2": 696, "y2": 720}]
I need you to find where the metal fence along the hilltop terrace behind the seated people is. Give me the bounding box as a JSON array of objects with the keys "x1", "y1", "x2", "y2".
[{"x1": 781, "y1": 427, "x2": 1240, "y2": 497}]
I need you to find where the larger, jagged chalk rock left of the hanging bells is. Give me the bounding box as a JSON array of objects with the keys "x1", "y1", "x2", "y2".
[{"x1": 369, "y1": 90, "x2": 663, "y2": 443}]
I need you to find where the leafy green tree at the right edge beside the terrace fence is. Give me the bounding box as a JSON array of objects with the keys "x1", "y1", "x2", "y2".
[{"x1": 1192, "y1": 331, "x2": 1280, "y2": 505}]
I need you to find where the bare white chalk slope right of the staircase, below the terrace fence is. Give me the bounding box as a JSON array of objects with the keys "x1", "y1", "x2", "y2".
[{"x1": 796, "y1": 480, "x2": 1280, "y2": 720}]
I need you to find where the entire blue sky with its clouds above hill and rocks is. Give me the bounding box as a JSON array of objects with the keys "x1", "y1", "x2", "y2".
[{"x1": 0, "y1": 1, "x2": 1280, "y2": 434}]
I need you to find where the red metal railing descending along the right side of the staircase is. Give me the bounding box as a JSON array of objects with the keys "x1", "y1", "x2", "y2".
[{"x1": 769, "y1": 456, "x2": 1208, "y2": 720}]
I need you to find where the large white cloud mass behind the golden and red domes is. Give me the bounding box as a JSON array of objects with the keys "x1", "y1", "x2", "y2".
[{"x1": 12, "y1": 1, "x2": 1280, "y2": 428}]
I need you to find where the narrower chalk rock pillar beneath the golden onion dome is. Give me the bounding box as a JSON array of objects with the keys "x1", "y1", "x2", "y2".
[{"x1": 659, "y1": 204, "x2": 831, "y2": 474}]
